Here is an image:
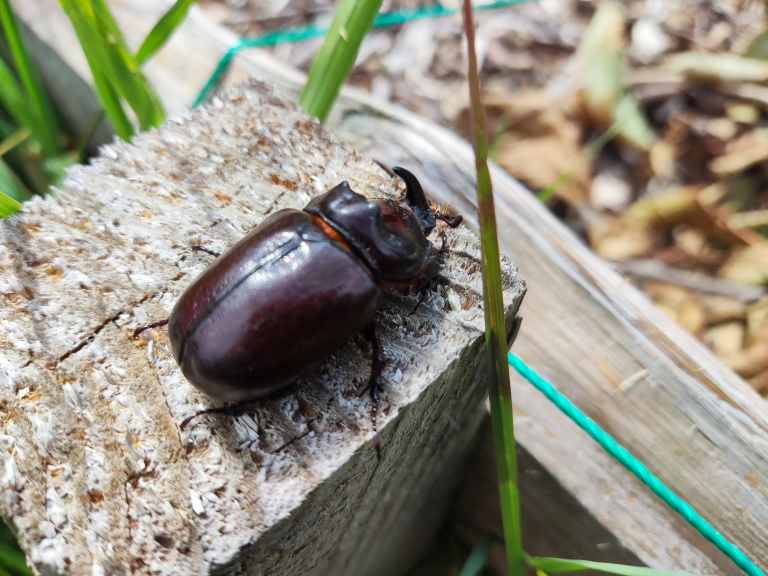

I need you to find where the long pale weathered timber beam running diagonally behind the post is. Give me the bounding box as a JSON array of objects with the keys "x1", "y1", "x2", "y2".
[{"x1": 10, "y1": 0, "x2": 768, "y2": 574}]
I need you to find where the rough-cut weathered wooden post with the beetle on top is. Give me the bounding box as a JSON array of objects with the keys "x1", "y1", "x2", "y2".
[{"x1": 0, "y1": 84, "x2": 524, "y2": 576}]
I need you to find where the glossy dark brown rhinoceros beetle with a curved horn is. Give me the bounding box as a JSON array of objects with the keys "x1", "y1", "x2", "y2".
[{"x1": 134, "y1": 168, "x2": 462, "y2": 455}]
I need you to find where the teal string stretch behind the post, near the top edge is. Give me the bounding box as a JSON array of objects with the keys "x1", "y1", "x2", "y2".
[{"x1": 198, "y1": 0, "x2": 531, "y2": 106}]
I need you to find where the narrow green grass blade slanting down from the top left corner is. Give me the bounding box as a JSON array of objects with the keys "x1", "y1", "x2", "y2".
[{"x1": 0, "y1": 0, "x2": 62, "y2": 154}]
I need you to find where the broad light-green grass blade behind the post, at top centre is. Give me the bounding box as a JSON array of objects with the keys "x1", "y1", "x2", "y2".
[{"x1": 299, "y1": 0, "x2": 381, "y2": 122}]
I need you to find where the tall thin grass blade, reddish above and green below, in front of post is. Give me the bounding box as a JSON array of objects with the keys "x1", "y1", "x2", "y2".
[{"x1": 463, "y1": 0, "x2": 523, "y2": 576}]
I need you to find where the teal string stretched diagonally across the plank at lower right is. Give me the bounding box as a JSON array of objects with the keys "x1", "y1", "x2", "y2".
[{"x1": 507, "y1": 352, "x2": 765, "y2": 576}]
